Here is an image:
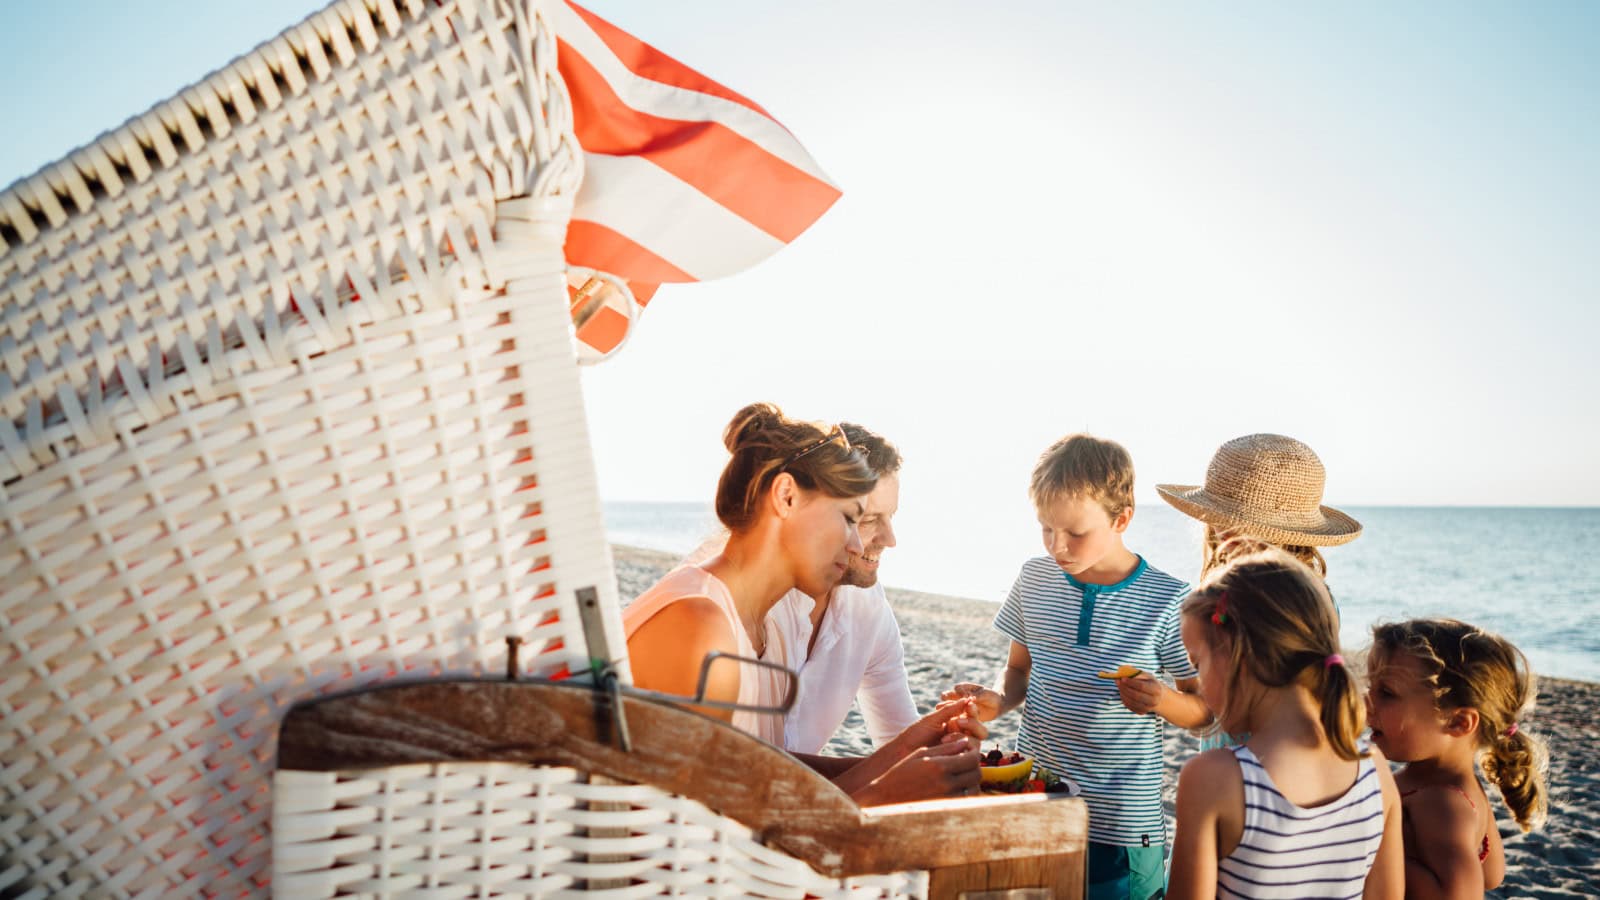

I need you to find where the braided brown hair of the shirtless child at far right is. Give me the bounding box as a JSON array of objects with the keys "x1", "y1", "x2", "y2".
[{"x1": 1366, "y1": 618, "x2": 1550, "y2": 831}]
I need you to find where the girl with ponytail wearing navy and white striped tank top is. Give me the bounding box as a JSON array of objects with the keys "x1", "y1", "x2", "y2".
[{"x1": 1166, "y1": 543, "x2": 1405, "y2": 898}]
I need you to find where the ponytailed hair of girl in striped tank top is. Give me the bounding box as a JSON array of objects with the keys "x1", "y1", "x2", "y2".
[{"x1": 1179, "y1": 541, "x2": 1365, "y2": 759}]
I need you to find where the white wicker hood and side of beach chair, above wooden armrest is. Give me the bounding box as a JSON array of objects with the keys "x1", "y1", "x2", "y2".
[{"x1": 0, "y1": 0, "x2": 621, "y2": 895}]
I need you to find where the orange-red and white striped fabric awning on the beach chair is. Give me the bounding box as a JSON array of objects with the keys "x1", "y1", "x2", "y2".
[{"x1": 555, "y1": 3, "x2": 840, "y2": 356}]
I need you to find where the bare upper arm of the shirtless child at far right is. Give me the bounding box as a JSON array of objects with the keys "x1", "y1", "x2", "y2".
[{"x1": 1405, "y1": 786, "x2": 1483, "y2": 900}]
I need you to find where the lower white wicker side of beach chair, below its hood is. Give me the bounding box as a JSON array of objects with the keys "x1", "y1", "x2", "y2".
[{"x1": 0, "y1": 273, "x2": 616, "y2": 890}]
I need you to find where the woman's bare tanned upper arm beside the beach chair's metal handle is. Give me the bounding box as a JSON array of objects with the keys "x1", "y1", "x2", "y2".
[{"x1": 627, "y1": 597, "x2": 739, "y2": 722}]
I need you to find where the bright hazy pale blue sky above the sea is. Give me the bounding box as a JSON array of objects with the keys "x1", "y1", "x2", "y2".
[{"x1": 0, "y1": 0, "x2": 1600, "y2": 533}]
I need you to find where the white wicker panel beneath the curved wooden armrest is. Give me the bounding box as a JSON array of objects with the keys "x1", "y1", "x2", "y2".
[{"x1": 272, "y1": 762, "x2": 928, "y2": 898}]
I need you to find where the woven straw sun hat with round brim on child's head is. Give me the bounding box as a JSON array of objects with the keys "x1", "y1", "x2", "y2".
[{"x1": 1155, "y1": 434, "x2": 1362, "y2": 546}]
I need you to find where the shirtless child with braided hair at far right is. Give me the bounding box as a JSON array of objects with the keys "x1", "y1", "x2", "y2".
[{"x1": 1366, "y1": 618, "x2": 1549, "y2": 897}]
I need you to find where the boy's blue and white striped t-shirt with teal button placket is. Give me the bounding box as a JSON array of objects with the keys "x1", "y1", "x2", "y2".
[{"x1": 995, "y1": 556, "x2": 1197, "y2": 847}]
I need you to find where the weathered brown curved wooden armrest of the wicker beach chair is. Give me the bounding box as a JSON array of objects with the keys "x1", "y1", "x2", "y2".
[{"x1": 278, "y1": 681, "x2": 1086, "y2": 894}]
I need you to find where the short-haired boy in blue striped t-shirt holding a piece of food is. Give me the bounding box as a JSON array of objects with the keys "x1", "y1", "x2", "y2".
[{"x1": 946, "y1": 434, "x2": 1211, "y2": 900}]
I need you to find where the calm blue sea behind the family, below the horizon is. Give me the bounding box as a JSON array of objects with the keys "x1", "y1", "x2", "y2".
[{"x1": 605, "y1": 501, "x2": 1600, "y2": 682}]
